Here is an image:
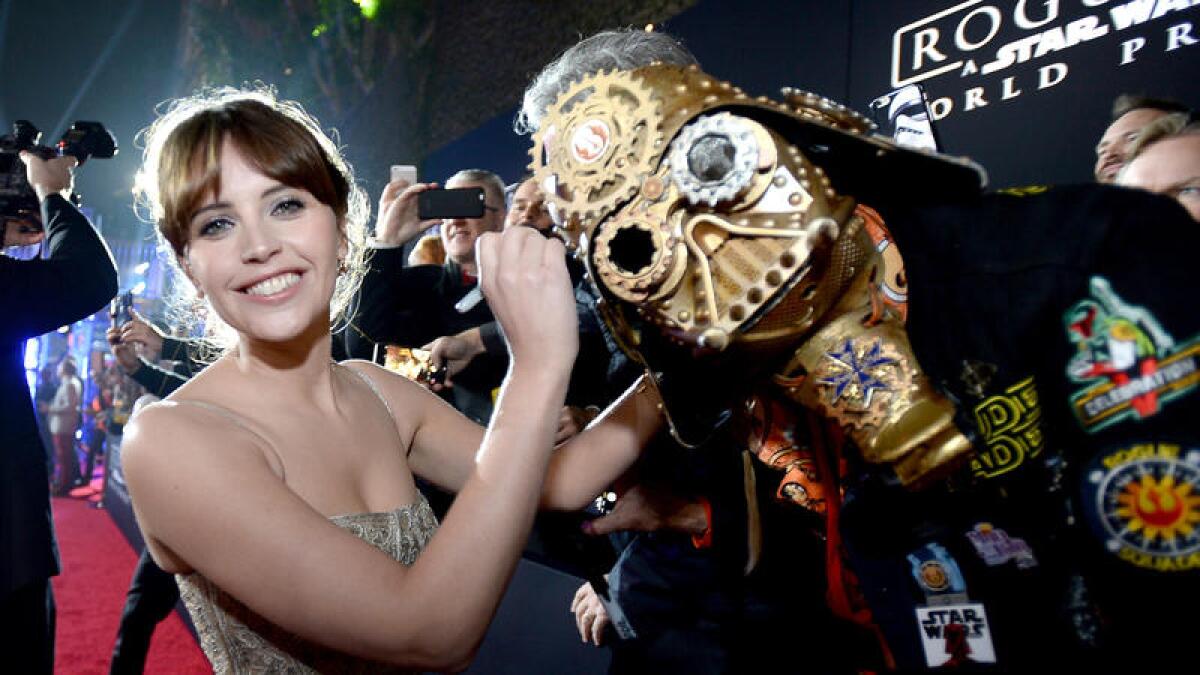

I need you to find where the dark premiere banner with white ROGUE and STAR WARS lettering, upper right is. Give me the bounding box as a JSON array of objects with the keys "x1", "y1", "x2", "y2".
[{"x1": 848, "y1": 0, "x2": 1200, "y2": 187}]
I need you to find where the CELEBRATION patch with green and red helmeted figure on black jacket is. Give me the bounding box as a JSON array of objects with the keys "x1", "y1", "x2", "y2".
[{"x1": 1063, "y1": 276, "x2": 1200, "y2": 432}]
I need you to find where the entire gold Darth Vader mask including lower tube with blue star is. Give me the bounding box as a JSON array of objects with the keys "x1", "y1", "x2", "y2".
[{"x1": 530, "y1": 65, "x2": 984, "y2": 480}]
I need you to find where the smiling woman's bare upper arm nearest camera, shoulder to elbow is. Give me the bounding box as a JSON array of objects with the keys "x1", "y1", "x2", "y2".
[{"x1": 122, "y1": 402, "x2": 506, "y2": 670}]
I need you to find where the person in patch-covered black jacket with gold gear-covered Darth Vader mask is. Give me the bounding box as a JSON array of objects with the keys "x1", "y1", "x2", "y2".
[{"x1": 522, "y1": 30, "x2": 1200, "y2": 671}]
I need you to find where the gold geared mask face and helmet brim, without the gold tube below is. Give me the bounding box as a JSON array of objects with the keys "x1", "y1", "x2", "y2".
[{"x1": 530, "y1": 65, "x2": 979, "y2": 353}]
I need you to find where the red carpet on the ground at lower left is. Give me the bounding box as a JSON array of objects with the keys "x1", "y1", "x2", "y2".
[{"x1": 54, "y1": 487, "x2": 212, "y2": 675}]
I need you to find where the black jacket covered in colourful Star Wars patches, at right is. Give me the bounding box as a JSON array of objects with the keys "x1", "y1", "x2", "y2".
[{"x1": 842, "y1": 185, "x2": 1200, "y2": 671}]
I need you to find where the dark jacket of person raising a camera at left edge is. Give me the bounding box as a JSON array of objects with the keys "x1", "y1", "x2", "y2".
[{"x1": 0, "y1": 195, "x2": 118, "y2": 595}]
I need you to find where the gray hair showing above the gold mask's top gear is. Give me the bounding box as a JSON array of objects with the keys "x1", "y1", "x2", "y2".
[{"x1": 512, "y1": 29, "x2": 697, "y2": 133}]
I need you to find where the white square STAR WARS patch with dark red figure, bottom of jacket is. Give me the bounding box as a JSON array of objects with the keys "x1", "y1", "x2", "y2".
[{"x1": 917, "y1": 603, "x2": 996, "y2": 668}]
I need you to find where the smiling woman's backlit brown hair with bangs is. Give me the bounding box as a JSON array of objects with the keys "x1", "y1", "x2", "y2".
[{"x1": 136, "y1": 89, "x2": 370, "y2": 348}]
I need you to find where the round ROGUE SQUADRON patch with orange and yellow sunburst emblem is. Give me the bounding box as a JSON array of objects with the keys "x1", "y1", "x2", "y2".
[{"x1": 1082, "y1": 443, "x2": 1200, "y2": 572}]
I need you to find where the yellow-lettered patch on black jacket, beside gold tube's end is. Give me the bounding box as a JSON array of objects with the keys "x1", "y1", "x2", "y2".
[{"x1": 971, "y1": 377, "x2": 1045, "y2": 478}]
